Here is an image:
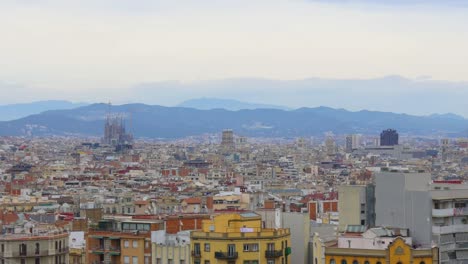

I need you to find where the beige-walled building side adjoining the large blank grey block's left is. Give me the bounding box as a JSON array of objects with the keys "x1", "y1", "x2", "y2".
[{"x1": 338, "y1": 184, "x2": 375, "y2": 231}]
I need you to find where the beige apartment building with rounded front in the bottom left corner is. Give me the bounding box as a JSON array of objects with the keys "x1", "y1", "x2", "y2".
[{"x1": 0, "y1": 223, "x2": 69, "y2": 264}]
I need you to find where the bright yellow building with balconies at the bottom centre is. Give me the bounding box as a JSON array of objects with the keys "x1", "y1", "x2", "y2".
[{"x1": 190, "y1": 213, "x2": 292, "y2": 264}]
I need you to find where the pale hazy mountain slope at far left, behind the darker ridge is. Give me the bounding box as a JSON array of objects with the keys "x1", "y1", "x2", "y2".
[{"x1": 0, "y1": 100, "x2": 86, "y2": 121}]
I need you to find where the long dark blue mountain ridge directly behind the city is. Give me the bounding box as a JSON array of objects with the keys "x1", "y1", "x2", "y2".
[{"x1": 0, "y1": 104, "x2": 468, "y2": 138}]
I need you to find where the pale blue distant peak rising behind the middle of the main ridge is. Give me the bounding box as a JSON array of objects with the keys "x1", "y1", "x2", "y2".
[{"x1": 177, "y1": 98, "x2": 290, "y2": 111}]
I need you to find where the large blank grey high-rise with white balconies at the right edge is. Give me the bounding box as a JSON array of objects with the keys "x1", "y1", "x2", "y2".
[{"x1": 375, "y1": 170, "x2": 468, "y2": 264}]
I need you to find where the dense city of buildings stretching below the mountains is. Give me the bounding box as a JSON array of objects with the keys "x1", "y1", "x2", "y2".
[{"x1": 0, "y1": 116, "x2": 468, "y2": 264}]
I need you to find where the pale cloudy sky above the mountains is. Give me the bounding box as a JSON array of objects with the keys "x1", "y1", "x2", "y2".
[{"x1": 0, "y1": 0, "x2": 468, "y2": 116}]
